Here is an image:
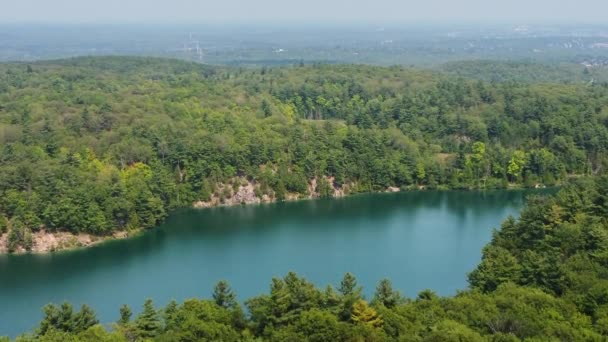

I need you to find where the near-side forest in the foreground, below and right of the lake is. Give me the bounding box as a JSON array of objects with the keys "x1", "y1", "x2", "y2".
[{"x1": 0, "y1": 176, "x2": 608, "y2": 342}]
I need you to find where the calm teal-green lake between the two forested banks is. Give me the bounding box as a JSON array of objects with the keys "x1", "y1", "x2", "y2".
[{"x1": 0, "y1": 190, "x2": 554, "y2": 336}]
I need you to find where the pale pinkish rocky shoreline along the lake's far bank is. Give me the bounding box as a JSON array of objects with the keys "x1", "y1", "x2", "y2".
[{"x1": 0, "y1": 178, "x2": 552, "y2": 256}]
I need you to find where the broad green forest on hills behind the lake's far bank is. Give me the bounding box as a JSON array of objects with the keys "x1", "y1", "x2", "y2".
[{"x1": 0, "y1": 57, "x2": 608, "y2": 250}]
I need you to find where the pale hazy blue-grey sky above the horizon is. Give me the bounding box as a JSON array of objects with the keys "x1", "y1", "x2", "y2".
[{"x1": 0, "y1": 0, "x2": 608, "y2": 24}]
